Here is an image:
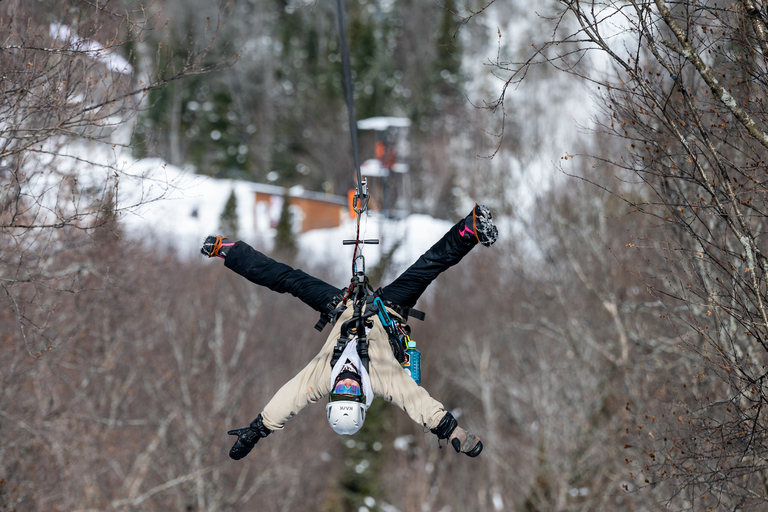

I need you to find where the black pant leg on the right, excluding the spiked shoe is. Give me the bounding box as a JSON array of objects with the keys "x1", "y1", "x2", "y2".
[{"x1": 381, "y1": 220, "x2": 477, "y2": 307}]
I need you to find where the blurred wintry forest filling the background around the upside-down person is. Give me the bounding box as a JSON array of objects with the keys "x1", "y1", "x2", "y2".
[{"x1": 0, "y1": 0, "x2": 768, "y2": 512}]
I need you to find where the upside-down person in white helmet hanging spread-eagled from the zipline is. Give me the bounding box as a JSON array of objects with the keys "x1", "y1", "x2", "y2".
[{"x1": 201, "y1": 204, "x2": 498, "y2": 460}]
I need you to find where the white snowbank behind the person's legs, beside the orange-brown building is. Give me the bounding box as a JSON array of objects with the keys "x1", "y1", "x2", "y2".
[{"x1": 19, "y1": 124, "x2": 462, "y2": 282}]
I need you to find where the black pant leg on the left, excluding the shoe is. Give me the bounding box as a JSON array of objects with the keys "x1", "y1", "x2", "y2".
[{"x1": 224, "y1": 241, "x2": 344, "y2": 313}]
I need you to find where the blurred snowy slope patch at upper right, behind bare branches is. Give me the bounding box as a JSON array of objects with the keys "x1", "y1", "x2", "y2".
[{"x1": 453, "y1": 2, "x2": 599, "y2": 219}]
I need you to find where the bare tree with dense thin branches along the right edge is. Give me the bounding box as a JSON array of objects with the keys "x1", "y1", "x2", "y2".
[{"x1": 468, "y1": 0, "x2": 768, "y2": 510}]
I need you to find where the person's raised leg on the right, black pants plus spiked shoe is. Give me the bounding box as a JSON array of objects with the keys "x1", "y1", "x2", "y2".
[{"x1": 381, "y1": 205, "x2": 498, "y2": 307}]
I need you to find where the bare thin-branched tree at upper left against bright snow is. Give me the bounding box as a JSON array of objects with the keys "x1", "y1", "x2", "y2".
[{"x1": 0, "y1": 0, "x2": 234, "y2": 355}]
